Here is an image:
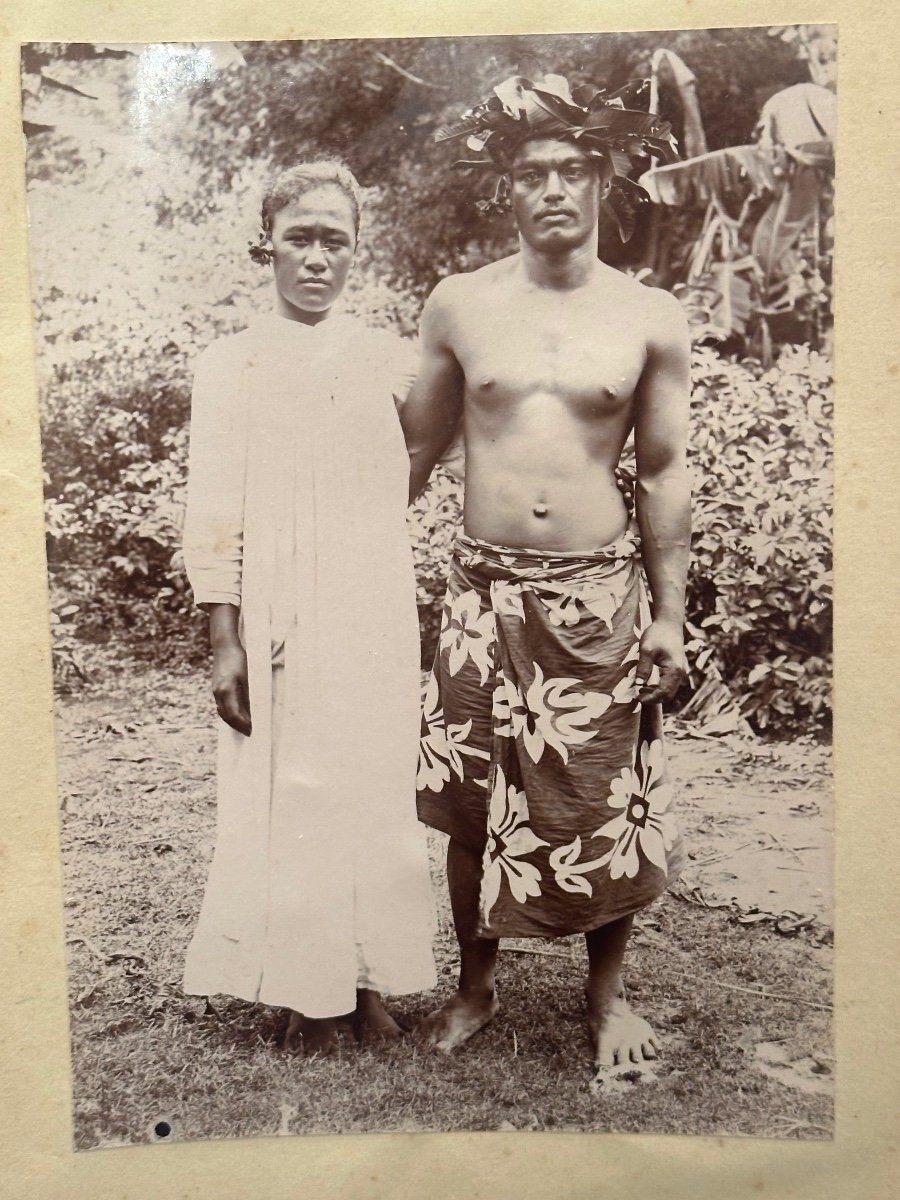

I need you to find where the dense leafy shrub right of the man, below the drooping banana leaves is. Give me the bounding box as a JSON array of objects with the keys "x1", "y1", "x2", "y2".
[{"x1": 688, "y1": 347, "x2": 832, "y2": 734}]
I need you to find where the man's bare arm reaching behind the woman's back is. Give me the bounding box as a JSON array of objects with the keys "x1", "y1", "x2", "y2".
[{"x1": 400, "y1": 280, "x2": 466, "y2": 504}]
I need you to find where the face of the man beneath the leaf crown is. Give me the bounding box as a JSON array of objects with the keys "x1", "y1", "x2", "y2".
[{"x1": 510, "y1": 138, "x2": 606, "y2": 252}]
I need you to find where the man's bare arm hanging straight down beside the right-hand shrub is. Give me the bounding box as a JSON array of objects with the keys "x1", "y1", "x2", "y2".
[{"x1": 635, "y1": 292, "x2": 691, "y2": 703}]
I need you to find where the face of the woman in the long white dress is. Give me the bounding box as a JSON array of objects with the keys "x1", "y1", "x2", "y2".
[{"x1": 271, "y1": 184, "x2": 356, "y2": 325}]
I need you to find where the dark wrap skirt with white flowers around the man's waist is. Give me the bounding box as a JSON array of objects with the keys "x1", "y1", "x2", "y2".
[{"x1": 418, "y1": 527, "x2": 684, "y2": 937}]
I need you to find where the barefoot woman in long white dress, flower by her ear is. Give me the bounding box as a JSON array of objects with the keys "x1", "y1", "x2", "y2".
[{"x1": 185, "y1": 162, "x2": 436, "y2": 1052}]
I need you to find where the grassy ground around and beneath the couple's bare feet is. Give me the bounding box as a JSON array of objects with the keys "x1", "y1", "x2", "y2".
[{"x1": 59, "y1": 664, "x2": 833, "y2": 1147}]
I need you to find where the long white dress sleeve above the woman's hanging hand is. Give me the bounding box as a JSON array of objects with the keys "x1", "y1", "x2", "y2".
[{"x1": 184, "y1": 343, "x2": 247, "y2": 607}]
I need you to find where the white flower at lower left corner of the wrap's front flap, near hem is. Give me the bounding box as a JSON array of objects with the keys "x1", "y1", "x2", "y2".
[{"x1": 481, "y1": 767, "x2": 548, "y2": 924}]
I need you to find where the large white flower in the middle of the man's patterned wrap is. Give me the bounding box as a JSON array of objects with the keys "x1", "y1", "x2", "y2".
[{"x1": 493, "y1": 662, "x2": 612, "y2": 762}]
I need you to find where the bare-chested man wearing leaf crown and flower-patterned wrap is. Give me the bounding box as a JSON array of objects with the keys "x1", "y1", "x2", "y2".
[{"x1": 402, "y1": 76, "x2": 690, "y2": 1069}]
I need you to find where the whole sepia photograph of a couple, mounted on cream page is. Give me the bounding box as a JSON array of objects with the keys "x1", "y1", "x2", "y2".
[{"x1": 20, "y1": 25, "x2": 838, "y2": 1151}]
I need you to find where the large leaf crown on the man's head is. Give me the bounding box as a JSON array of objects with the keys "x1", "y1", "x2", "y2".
[{"x1": 434, "y1": 64, "x2": 678, "y2": 241}]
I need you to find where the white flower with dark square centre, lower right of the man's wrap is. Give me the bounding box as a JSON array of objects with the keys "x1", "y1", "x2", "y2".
[{"x1": 594, "y1": 738, "x2": 677, "y2": 880}]
